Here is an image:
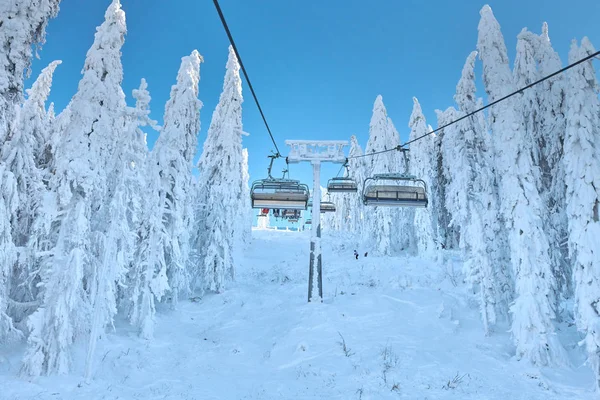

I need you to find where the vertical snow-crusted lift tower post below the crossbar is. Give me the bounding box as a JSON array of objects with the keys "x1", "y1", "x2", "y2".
[{"x1": 308, "y1": 160, "x2": 323, "y2": 303}]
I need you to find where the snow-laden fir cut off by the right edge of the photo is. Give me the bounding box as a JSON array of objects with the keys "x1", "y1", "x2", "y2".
[{"x1": 564, "y1": 38, "x2": 600, "y2": 389}]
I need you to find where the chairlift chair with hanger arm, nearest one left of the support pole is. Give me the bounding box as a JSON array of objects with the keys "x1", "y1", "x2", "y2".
[{"x1": 250, "y1": 154, "x2": 309, "y2": 210}]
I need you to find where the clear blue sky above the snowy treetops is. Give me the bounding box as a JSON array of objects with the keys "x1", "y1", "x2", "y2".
[{"x1": 28, "y1": 0, "x2": 600, "y2": 211}]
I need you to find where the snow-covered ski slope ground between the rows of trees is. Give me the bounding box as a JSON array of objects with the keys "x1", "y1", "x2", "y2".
[{"x1": 0, "y1": 230, "x2": 595, "y2": 400}]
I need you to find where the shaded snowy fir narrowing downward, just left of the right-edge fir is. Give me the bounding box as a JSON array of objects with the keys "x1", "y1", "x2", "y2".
[{"x1": 513, "y1": 23, "x2": 571, "y2": 300}]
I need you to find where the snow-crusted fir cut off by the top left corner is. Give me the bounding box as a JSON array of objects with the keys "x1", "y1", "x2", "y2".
[{"x1": 0, "y1": 0, "x2": 60, "y2": 144}]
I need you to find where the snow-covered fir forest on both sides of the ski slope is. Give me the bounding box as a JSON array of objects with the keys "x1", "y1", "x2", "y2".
[{"x1": 0, "y1": 0, "x2": 600, "y2": 392}]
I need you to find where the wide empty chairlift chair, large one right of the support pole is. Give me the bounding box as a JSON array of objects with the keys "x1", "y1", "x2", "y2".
[{"x1": 363, "y1": 174, "x2": 429, "y2": 207}]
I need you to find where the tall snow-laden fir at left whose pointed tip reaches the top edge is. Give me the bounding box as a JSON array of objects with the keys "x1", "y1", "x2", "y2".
[{"x1": 24, "y1": 0, "x2": 126, "y2": 375}]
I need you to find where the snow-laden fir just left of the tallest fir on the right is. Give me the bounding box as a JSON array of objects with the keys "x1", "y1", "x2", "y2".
[{"x1": 438, "y1": 52, "x2": 512, "y2": 334}]
